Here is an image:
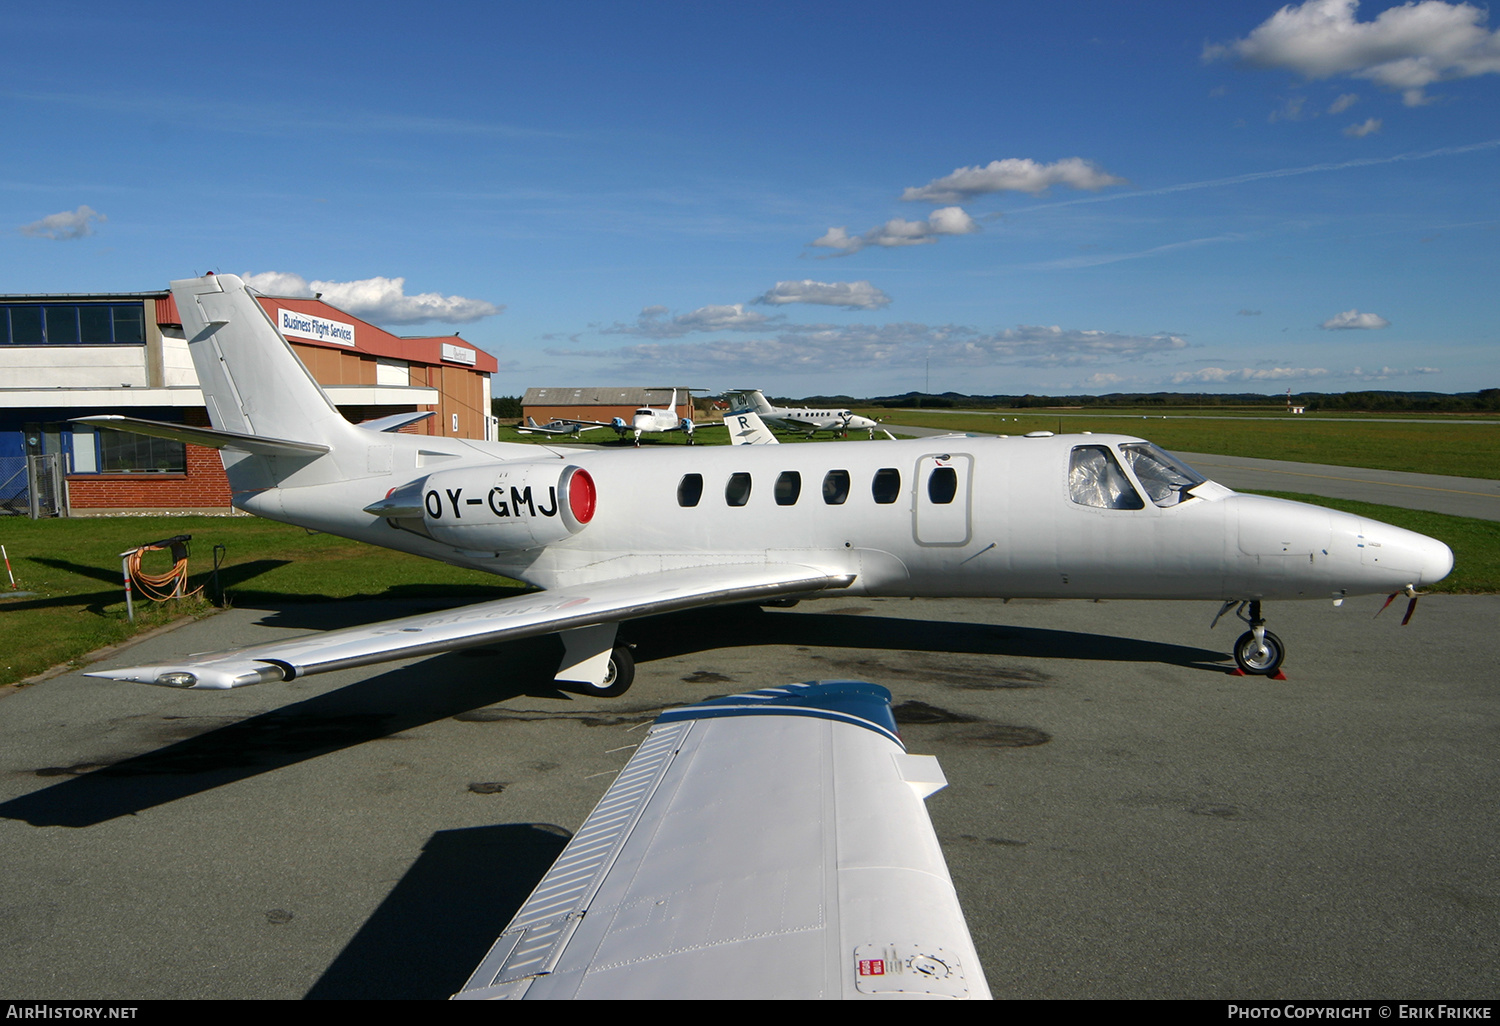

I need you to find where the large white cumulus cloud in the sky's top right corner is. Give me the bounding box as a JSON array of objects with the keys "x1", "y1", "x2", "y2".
[{"x1": 1203, "y1": 0, "x2": 1500, "y2": 107}]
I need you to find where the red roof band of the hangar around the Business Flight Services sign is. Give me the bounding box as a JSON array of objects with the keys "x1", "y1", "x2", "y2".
[{"x1": 156, "y1": 294, "x2": 500, "y2": 374}]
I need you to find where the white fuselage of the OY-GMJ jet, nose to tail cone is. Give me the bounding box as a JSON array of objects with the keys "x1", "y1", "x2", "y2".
[{"x1": 239, "y1": 435, "x2": 1452, "y2": 600}]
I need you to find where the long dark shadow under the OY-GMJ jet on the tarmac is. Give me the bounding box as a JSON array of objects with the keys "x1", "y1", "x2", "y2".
[{"x1": 0, "y1": 603, "x2": 1226, "y2": 827}]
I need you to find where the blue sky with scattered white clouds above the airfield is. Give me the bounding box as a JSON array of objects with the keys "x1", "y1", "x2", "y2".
[{"x1": 0, "y1": 0, "x2": 1500, "y2": 396}]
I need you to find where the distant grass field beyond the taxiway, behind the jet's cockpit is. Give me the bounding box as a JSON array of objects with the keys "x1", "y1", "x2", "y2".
[{"x1": 858, "y1": 410, "x2": 1500, "y2": 480}]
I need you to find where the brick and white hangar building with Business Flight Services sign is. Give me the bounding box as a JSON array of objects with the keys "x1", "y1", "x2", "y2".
[{"x1": 0, "y1": 290, "x2": 497, "y2": 515}]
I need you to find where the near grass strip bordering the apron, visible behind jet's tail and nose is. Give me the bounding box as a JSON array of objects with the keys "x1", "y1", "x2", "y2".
[{"x1": 0, "y1": 492, "x2": 1500, "y2": 684}]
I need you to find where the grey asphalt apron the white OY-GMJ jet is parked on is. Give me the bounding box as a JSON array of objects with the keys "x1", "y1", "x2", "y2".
[{"x1": 0, "y1": 596, "x2": 1500, "y2": 999}]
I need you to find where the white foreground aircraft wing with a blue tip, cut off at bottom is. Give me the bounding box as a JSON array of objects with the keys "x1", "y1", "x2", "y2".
[{"x1": 455, "y1": 681, "x2": 990, "y2": 999}]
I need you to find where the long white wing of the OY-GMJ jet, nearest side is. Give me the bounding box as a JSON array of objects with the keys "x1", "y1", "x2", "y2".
[{"x1": 89, "y1": 563, "x2": 854, "y2": 690}]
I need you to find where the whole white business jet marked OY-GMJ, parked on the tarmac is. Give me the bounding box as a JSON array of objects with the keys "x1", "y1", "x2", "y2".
[{"x1": 86, "y1": 275, "x2": 1454, "y2": 696}]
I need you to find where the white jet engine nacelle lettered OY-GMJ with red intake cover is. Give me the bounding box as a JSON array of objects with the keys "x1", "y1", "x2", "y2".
[{"x1": 371, "y1": 464, "x2": 599, "y2": 551}]
